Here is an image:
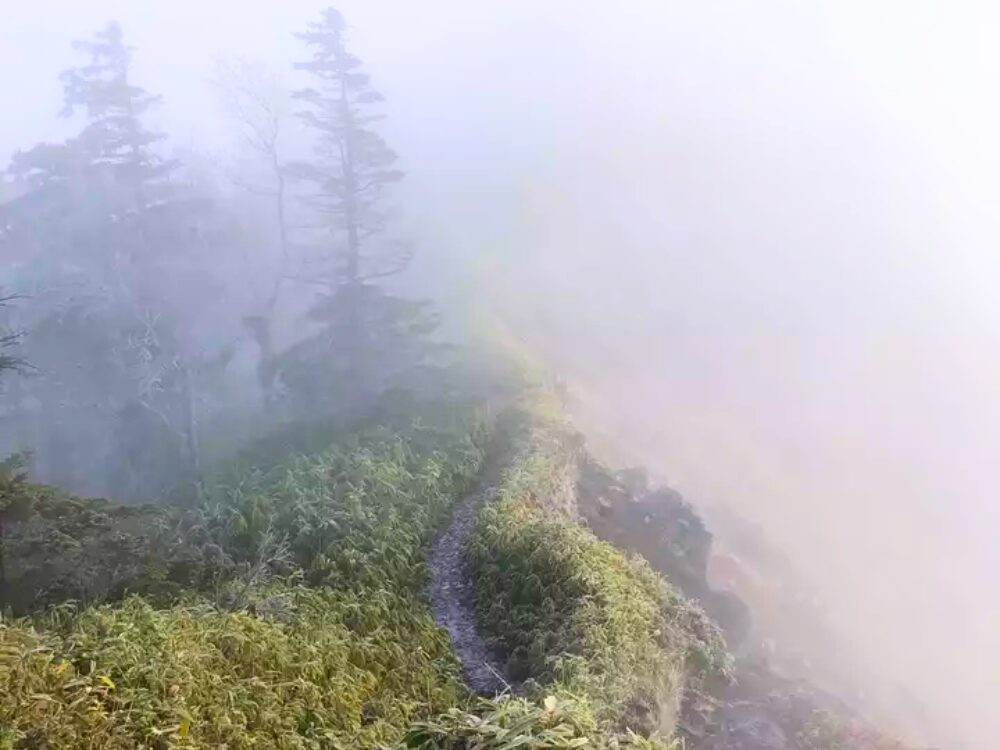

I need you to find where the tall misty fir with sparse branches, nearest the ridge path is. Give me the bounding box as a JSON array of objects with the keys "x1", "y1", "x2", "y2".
[{"x1": 280, "y1": 8, "x2": 437, "y2": 415}]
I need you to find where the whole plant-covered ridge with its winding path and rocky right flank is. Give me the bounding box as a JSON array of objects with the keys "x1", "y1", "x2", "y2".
[{"x1": 0, "y1": 392, "x2": 920, "y2": 750}]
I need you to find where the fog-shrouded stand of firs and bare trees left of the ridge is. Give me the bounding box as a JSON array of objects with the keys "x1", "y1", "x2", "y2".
[{"x1": 0, "y1": 8, "x2": 458, "y2": 501}]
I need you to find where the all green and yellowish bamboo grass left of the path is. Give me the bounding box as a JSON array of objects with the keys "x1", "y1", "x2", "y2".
[{"x1": 0, "y1": 415, "x2": 485, "y2": 750}]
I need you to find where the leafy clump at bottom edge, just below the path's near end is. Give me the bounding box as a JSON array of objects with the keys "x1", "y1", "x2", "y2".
[{"x1": 399, "y1": 695, "x2": 677, "y2": 750}]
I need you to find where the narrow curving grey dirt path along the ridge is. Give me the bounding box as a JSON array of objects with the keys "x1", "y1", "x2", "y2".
[{"x1": 429, "y1": 490, "x2": 510, "y2": 696}]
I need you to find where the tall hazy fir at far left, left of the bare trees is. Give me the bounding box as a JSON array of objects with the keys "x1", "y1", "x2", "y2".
[{"x1": 0, "y1": 23, "x2": 211, "y2": 499}]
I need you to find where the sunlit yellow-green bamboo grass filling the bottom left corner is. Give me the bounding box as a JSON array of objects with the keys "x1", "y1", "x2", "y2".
[{"x1": 0, "y1": 588, "x2": 462, "y2": 750}]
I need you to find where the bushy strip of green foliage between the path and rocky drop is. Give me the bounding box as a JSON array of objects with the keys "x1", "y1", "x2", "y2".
[{"x1": 470, "y1": 406, "x2": 730, "y2": 736}]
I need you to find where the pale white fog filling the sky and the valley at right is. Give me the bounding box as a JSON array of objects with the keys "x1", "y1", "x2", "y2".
[{"x1": 0, "y1": 0, "x2": 1000, "y2": 750}]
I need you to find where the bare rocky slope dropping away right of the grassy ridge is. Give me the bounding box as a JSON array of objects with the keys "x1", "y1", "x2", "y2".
[{"x1": 500, "y1": 394, "x2": 920, "y2": 750}]
